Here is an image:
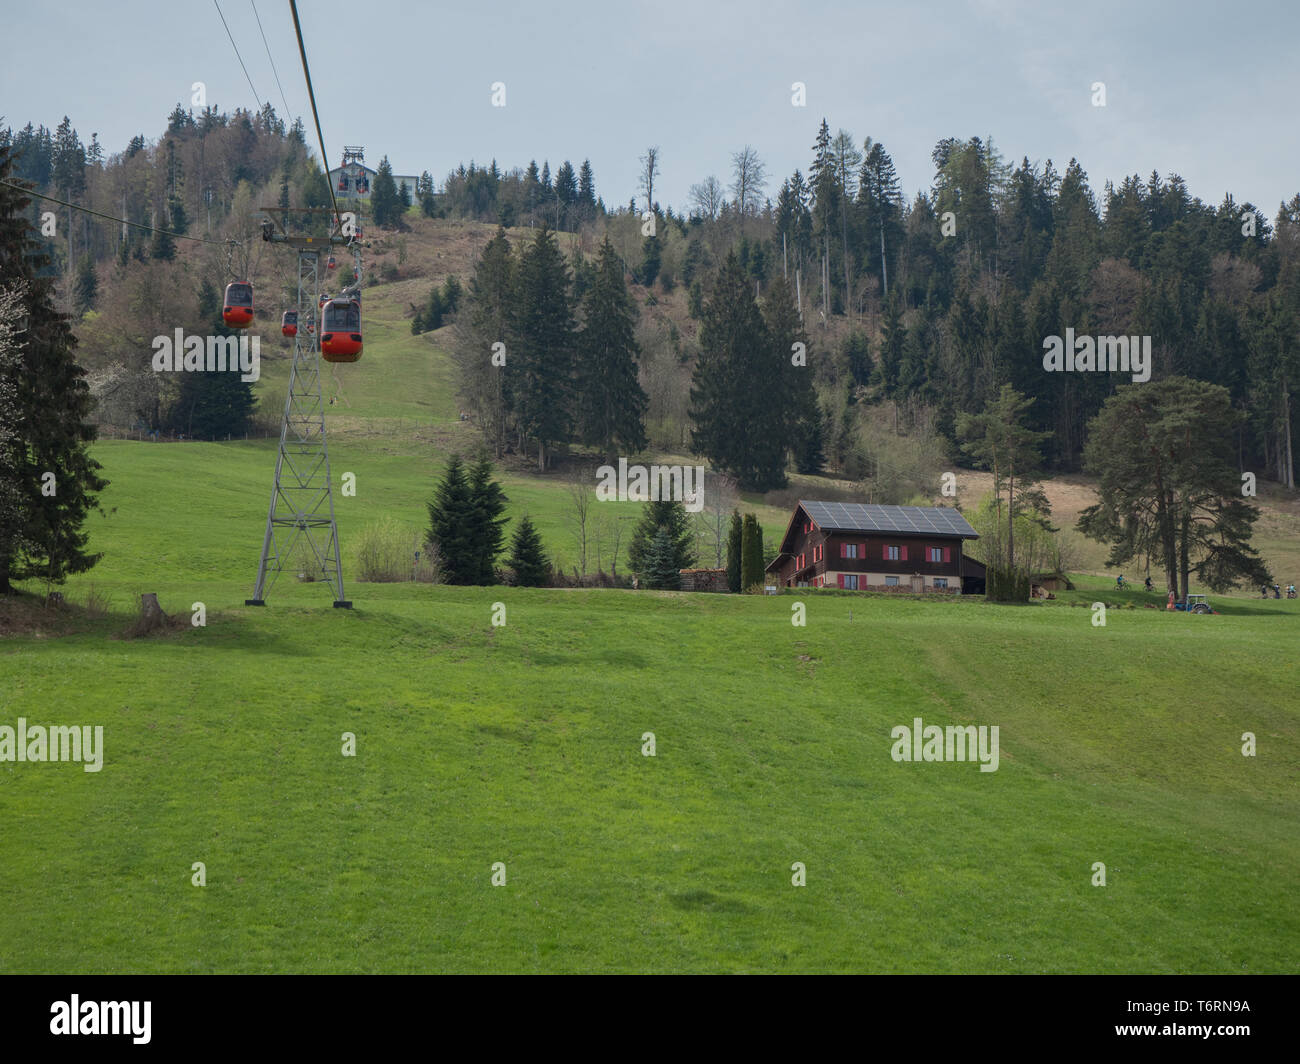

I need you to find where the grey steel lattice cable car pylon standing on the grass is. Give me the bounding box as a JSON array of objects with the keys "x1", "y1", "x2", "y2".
[{"x1": 244, "y1": 248, "x2": 352, "y2": 609}]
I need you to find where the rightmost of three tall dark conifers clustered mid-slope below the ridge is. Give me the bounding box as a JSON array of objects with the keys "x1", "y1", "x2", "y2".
[{"x1": 576, "y1": 237, "x2": 649, "y2": 463}]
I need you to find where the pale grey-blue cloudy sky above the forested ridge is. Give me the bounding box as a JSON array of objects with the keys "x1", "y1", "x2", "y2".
[{"x1": 0, "y1": 0, "x2": 1300, "y2": 219}]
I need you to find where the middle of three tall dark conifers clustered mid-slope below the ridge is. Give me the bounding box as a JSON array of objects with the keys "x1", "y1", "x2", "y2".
[{"x1": 507, "y1": 225, "x2": 575, "y2": 472}]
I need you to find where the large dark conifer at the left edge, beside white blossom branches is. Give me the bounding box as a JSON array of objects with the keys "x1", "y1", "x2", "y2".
[{"x1": 0, "y1": 146, "x2": 108, "y2": 593}]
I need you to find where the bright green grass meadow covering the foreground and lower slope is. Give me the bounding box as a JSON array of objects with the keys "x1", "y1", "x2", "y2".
[{"x1": 0, "y1": 271, "x2": 1300, "y2": 973}]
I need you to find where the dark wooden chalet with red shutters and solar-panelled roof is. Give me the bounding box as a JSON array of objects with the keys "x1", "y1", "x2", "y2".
[{"x1": 767, "y1": 499, "x2": 984, "y2": 594}]
